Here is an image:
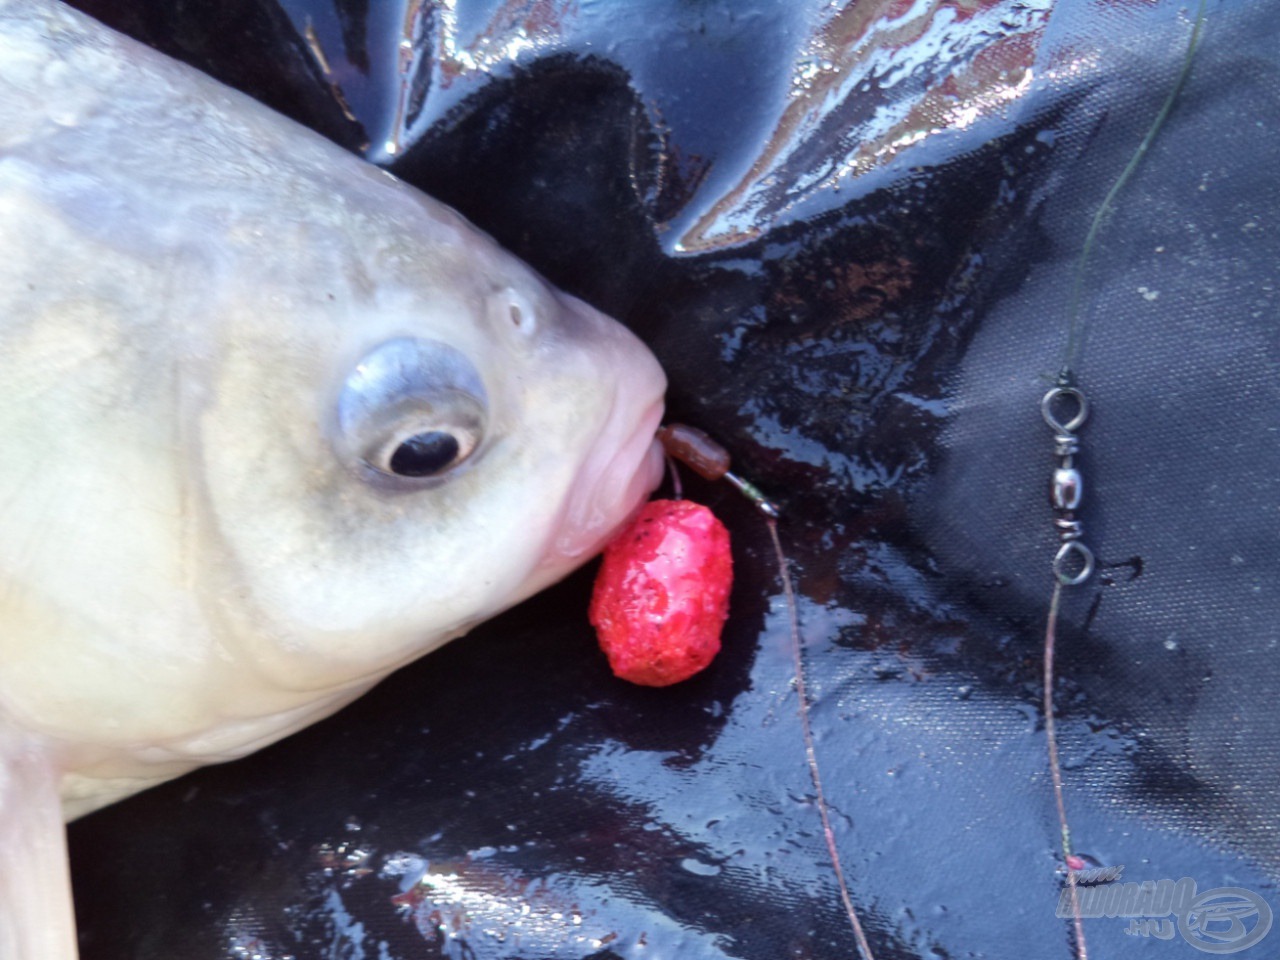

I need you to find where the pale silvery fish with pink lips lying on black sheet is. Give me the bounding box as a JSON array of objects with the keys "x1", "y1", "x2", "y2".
[{"x1": 0, "y1": 0, "x2": 666, "y2": 960}]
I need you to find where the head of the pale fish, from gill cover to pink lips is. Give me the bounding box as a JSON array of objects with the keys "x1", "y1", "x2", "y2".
[{"x1": 193, "y1": 186, "x2": 666, "y2": 686}]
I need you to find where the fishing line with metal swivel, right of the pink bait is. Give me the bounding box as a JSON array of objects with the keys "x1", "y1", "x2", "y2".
[{"x1": 1041, "y1": 7, "x2": 1208, "y2": 960}]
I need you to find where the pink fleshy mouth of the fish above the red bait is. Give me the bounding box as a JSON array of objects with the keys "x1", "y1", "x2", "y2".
[{"x1": 548, "y1": 398, "x2": 664, "y2": 563}]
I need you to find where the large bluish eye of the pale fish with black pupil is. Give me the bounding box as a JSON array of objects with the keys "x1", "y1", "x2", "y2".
[{"x1": 335, "y1": 337, "x2": 488, "y2": 489}]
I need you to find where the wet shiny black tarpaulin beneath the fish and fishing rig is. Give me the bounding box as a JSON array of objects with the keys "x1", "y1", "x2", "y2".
[{"x1": 62, "y1": 0, "x2": 1280, "y2": 960}]
